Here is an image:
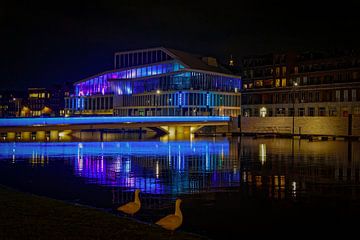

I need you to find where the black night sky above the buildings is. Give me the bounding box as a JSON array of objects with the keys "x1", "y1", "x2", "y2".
[{"x1": 0, "y1": 0, "x2": 360, "y2": 90}]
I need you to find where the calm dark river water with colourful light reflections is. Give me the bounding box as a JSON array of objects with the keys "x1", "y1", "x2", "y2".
[{"x1": 0, "y1": 137, "x2": 360, "y2": 239}]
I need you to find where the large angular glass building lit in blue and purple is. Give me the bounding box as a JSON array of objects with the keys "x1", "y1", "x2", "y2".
[{"x1": 65, "y1": 47, "x2": 241, "y2": 116}]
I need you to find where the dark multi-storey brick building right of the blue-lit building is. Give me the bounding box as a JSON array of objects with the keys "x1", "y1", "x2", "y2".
[{"x1": 242, "y1": 51, "x2": 360, "y2": 117}]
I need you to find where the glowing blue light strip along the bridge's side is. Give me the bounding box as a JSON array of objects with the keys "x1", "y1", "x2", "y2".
[{"x1": 0, "y1": 116, "x2": 230, "y2": 127}]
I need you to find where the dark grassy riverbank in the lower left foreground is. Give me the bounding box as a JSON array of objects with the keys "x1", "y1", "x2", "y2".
[{"x1": 0, "y1": 185, "x2": 205, "y2": 240}]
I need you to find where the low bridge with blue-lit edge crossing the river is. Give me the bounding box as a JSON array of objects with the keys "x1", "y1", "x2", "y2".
[{"x1": 0, "y1": 116, "x2": 230, "y2": 140}]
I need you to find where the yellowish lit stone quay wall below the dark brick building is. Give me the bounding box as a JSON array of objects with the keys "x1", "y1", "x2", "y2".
[{"x1": 236, "y1": 117, "x2": 360, "y2": 136}]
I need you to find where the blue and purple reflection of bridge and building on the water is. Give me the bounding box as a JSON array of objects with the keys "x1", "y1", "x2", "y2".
[{"x1": 0, "y1": 141, "x2": 240, "y2": 194}]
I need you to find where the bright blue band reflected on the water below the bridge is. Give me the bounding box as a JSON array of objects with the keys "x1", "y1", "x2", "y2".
[{"x1": 0, "y1": 140, "x2": 230, "y2": 159}]
